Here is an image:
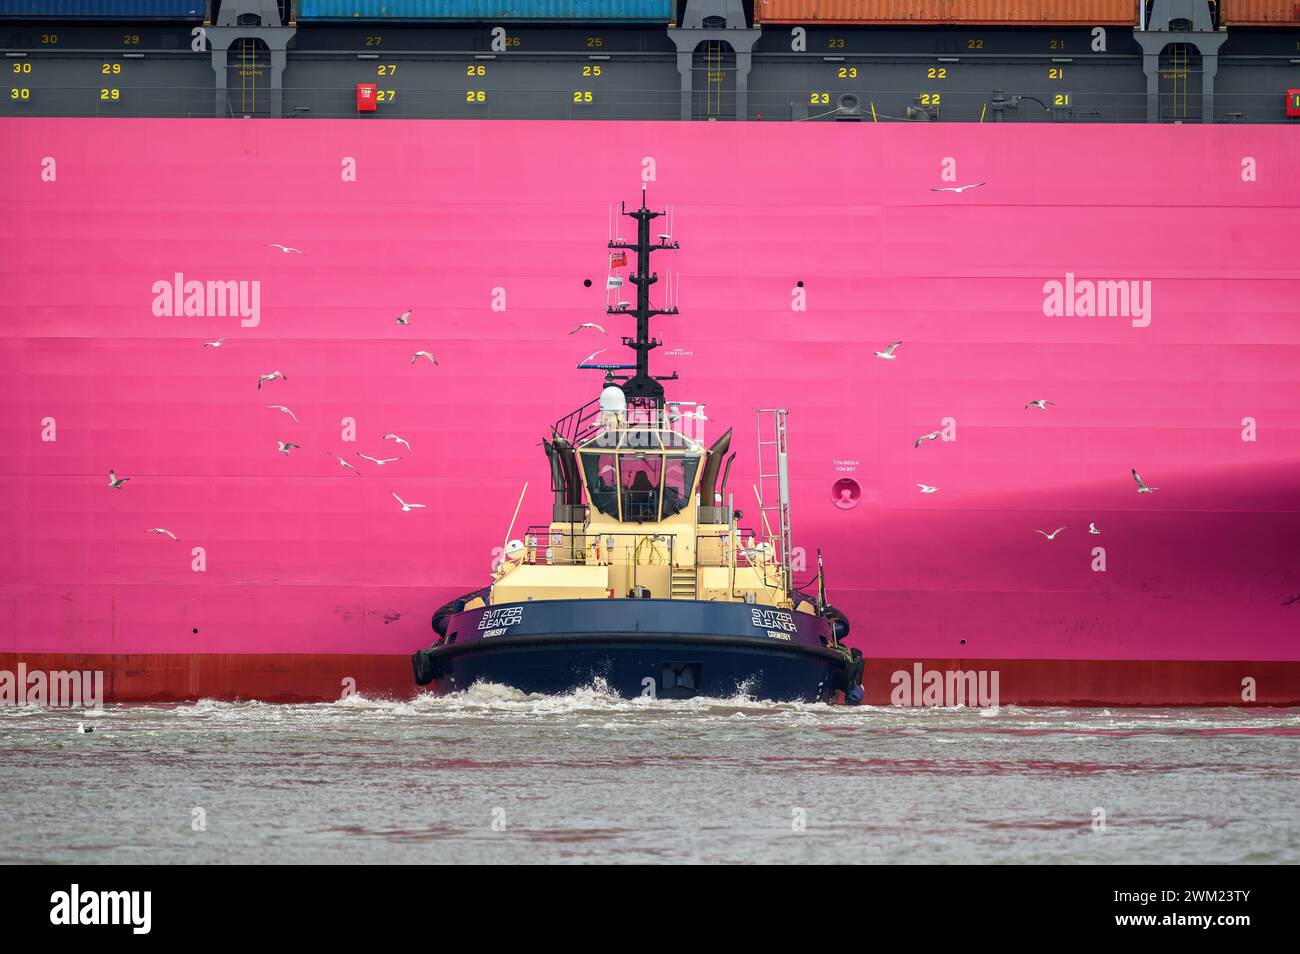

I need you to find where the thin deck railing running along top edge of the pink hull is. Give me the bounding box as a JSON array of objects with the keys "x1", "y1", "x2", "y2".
[{"x1": 0, "y1": 84, "x2": 1296, "y2": 123}]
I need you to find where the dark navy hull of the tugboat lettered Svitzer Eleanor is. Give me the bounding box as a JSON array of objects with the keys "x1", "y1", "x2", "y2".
[{"x1": 412, "y1": 599, "x2": 846, "y2": 702}]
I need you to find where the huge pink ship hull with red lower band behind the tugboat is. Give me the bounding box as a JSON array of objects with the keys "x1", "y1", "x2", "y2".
[{"x1": 0, "y1": 120, "x2": 1300, "y2": 704}]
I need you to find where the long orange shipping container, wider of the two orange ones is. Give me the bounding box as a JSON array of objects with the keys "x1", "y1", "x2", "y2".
[{"x1": 754, "y1": 0, "x2": 1138, "y2": 26}]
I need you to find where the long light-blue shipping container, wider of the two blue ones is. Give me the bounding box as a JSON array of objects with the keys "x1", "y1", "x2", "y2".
[{"x1": 298, "y1": 0, "x2": 673, "y2": 23}]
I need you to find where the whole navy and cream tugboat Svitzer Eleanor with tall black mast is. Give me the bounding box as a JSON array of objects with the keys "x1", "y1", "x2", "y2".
[{"x1": 412, "y1": 187, "x2": 863, "y2": 704}]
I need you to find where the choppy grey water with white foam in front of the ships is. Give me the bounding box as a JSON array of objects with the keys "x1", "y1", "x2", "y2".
[{"x1": 0, "y1": 686, "x2": 1300, "y2": 863}]
